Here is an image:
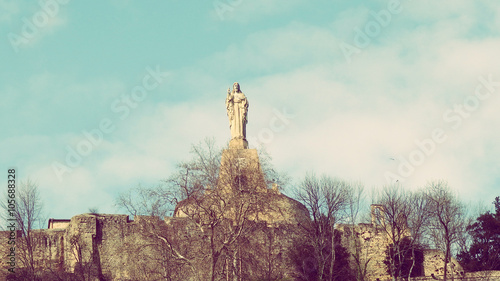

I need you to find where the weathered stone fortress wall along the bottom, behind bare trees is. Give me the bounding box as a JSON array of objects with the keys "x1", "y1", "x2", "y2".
[{"x1": 0, "y1": 201, "x2": 500, "y2": 280}]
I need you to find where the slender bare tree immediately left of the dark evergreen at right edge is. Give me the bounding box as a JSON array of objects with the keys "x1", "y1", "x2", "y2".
[{"x1": 426, "y1": 181, "x2": 465, "y2": 281}]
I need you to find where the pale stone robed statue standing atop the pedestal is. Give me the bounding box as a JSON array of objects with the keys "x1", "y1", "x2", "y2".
[{"x1": 226, "y1": 82, "x2": 248, "y2": 149}]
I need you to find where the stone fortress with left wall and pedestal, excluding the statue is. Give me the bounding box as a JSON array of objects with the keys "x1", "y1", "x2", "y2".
[{"x1": 1, "y1": 145, "x2": 309, "y2": 280}]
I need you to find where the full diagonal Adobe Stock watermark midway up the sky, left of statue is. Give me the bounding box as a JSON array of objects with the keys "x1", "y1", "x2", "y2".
[{"x1": 52, "y1": 66, "x2": 169, "y2": 181}]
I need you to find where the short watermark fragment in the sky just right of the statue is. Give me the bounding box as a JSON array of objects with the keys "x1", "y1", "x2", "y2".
[{"x1": 248, "y1": 108, "x2": 295, "y2": 147}]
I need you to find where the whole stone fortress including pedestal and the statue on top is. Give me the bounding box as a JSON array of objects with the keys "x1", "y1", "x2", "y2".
[{"x1": 0, "y1": 83, "x2": 496, "y2": 281}]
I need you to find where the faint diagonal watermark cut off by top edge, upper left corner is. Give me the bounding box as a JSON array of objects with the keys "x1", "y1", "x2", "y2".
[{"x1": 7, "y1": 0, "x2": 70, "y2": 53}]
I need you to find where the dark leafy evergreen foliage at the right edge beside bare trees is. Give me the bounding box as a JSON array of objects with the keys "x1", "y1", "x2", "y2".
[{"x1": 458, "y1": 197, "x2": 500, "y2": 272}]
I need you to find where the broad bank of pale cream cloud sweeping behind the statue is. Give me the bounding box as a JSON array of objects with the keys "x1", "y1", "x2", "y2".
[{"x1": 0, "y1": 1, "x2": 500, "y2": 220}]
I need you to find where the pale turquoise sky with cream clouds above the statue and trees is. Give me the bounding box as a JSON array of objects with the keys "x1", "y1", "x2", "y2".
[{"x1": 0, "y1": 0, "x2": 500, "y2": 222}]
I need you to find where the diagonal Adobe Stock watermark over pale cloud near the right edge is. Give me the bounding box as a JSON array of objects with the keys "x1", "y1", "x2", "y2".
[{"x1": 384, "y1": 74, "x2": 500, "y2": 184}]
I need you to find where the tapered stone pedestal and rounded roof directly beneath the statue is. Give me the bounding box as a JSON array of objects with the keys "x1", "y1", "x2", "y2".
[{"x1": 174, "y1": 145, "x2": 310, "y2": 225}]
